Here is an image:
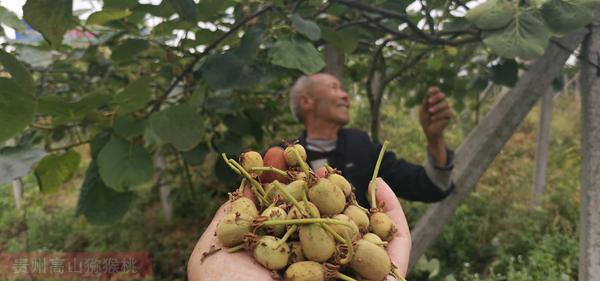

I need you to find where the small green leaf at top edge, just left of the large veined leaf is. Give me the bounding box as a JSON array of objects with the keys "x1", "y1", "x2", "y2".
[{"x1": 466, "y1": 0, "x2": 515, "y2": 30}]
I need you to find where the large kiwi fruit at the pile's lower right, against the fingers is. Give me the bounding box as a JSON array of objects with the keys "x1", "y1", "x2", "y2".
[{"x1": 350, "y1": 239, "x2": 392, "y2": 281}]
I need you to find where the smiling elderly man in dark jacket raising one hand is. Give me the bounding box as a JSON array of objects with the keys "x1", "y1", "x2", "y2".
[{"x1": 290, "y1": 73, "x2": 453, "y2": 206}]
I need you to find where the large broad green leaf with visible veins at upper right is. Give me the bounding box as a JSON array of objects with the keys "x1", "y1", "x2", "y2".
[{"x1": 483, "y1": 7, "x2": 551, "y2": 59}]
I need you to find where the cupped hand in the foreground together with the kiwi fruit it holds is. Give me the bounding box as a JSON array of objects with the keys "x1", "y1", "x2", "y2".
[{"x1": 188, "y1": 145, "x2": 411, "y2": 281}]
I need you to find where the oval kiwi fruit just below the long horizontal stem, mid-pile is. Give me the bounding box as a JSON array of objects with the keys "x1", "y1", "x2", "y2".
[{"x1": 299, "y1": 224, "x2": 335, "y2": 262}]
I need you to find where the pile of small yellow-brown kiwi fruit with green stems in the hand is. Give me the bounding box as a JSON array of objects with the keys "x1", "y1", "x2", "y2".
[{"x1": 216, "y1": 142, "x2": 404, "y2": 281}]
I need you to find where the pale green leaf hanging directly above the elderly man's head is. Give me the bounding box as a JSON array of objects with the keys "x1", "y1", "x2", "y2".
[{"x1": 270, "y1": 39, "x2": 325, "y2": 74}]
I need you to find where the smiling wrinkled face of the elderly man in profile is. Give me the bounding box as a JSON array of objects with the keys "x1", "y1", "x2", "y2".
[{"x1": 310, "y1": 73, "x2": 350, "y2": 126}]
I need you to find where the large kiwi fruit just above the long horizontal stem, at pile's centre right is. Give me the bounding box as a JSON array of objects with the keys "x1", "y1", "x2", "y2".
[{"x1": 308, "y1": 179, "x2": 346, "y2": 216}]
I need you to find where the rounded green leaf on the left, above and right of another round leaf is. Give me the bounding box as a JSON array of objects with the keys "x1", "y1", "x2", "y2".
[{"x1": 150, "y1": 104, "x2": 204, "y2": 151}]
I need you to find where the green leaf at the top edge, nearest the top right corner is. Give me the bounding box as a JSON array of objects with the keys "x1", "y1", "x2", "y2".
[{"x1": 541, "y1": 0, "x2": 593, "y2": 34}]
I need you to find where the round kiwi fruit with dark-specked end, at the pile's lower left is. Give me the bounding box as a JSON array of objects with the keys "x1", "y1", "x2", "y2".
[{"x1": 253, "y1": 235, "x2": 290, "y2": 270}]
